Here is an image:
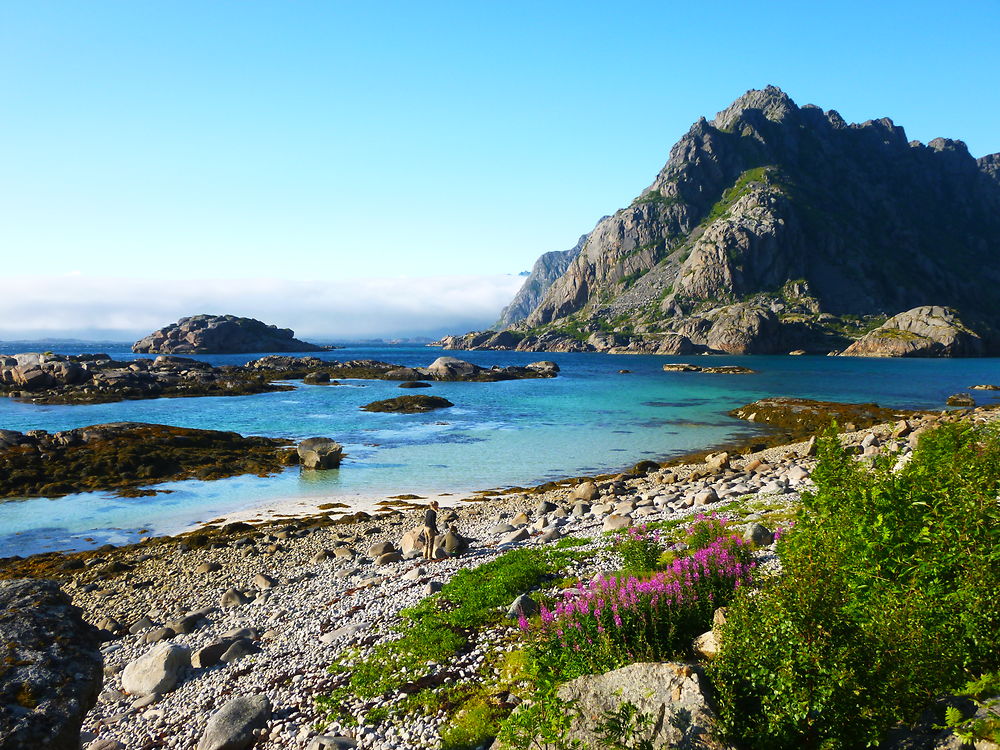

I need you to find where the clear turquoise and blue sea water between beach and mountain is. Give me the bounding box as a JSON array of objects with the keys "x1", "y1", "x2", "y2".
[{"x1": 0, "y1": 343, "x2": 1000, "y2": 557}]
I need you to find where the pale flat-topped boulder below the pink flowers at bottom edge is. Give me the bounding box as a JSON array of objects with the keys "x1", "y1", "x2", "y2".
[{"x1": 558, "y1": 662, "x2": 731, "y2": 750}]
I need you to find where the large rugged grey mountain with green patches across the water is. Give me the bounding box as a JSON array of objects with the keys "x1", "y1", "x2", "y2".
[{"x1": 445, "y1": 86, "x2": 1000, "y2": 356}]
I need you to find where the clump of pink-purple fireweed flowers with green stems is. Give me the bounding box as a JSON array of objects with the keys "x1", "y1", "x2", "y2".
[{"x1": 519, "y1": 536, "x2": 754, "y2": 679}]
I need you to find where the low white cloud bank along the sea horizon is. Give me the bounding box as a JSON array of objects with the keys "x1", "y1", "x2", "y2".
[{"x1": 0, "y1": 275, "x2": 524, "y2": 341}]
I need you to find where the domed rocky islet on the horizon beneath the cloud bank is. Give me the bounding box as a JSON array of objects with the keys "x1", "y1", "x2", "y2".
[{"x1": 132, "y1": 315, "x2": 325, "y2": 354}]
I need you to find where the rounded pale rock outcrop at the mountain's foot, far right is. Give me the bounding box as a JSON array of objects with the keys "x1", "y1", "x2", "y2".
[{"x1": 841, "y1": 306, "x2": 986, "y2": 357}]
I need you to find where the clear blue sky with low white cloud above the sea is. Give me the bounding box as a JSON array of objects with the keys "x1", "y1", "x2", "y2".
[{"x1": 0, "y1": 0, "x2": 1000, "y2": 339}]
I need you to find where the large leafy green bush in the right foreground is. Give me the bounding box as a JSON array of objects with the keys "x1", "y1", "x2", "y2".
[{"x1": 711, "y1": 425, "x2": 1000, "y2": 750}]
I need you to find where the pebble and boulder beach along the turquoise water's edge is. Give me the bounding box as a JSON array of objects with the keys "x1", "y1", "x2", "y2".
[{"x1": 0, "y1": 400, "x2": 1000, "y2": 750}]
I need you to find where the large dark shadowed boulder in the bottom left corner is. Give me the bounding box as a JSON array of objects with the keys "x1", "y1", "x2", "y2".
[{"x1": 0, "y1": 580, "x2": 103, "y2": 750}]
